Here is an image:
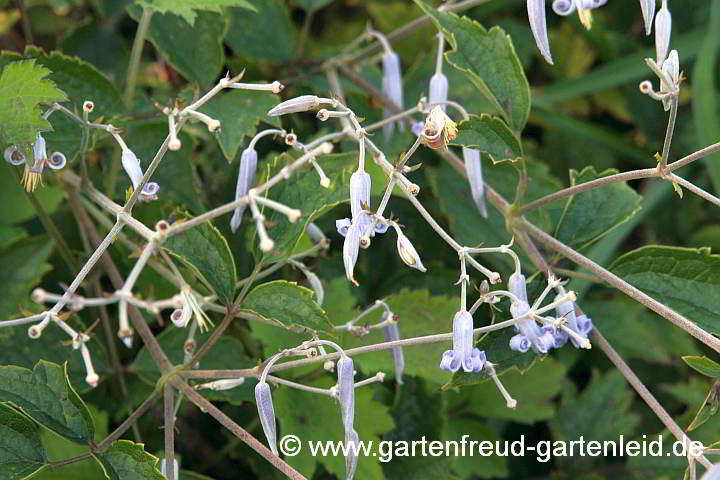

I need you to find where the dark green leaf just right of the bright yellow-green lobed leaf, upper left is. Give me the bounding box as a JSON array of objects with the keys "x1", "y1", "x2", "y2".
[{"x1": 25, "y1": 47, "x2": 122, "y2": 118}]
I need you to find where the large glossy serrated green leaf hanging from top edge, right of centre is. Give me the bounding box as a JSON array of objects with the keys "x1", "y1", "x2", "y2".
[{"x1": 415, "y1": 0, "x2": 530, "y2": 132}]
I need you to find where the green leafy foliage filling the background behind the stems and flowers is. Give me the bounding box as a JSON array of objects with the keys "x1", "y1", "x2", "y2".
[{"x1": 0, "y1": 0, "x2": 720, "y2": 480}]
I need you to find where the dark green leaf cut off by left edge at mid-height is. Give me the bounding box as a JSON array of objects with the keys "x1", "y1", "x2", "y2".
[{"x1": 0, "y1": 237, "x2": 53, "y2": 322}]
